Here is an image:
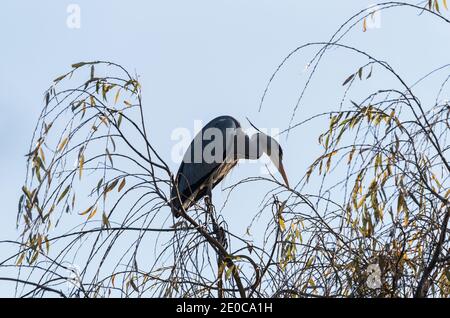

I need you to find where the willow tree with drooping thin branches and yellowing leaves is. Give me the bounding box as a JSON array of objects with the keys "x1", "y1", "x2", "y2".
[{"x1": 0, "y1": 1, "x2": 450, "y2": 297}]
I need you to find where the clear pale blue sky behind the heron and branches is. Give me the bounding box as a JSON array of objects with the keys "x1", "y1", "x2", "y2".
[{"x1": 0, "y1": 0, "x2": 450, "y2": 295}]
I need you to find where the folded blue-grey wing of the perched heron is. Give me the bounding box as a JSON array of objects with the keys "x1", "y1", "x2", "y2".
[{"x1": 171, "y1": 116, "x2": 240, "y2": 210}]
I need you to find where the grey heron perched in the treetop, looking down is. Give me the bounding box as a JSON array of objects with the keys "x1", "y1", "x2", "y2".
[{"x1": 171, "y1": 116, "x2": 289, "y2": 217}]
